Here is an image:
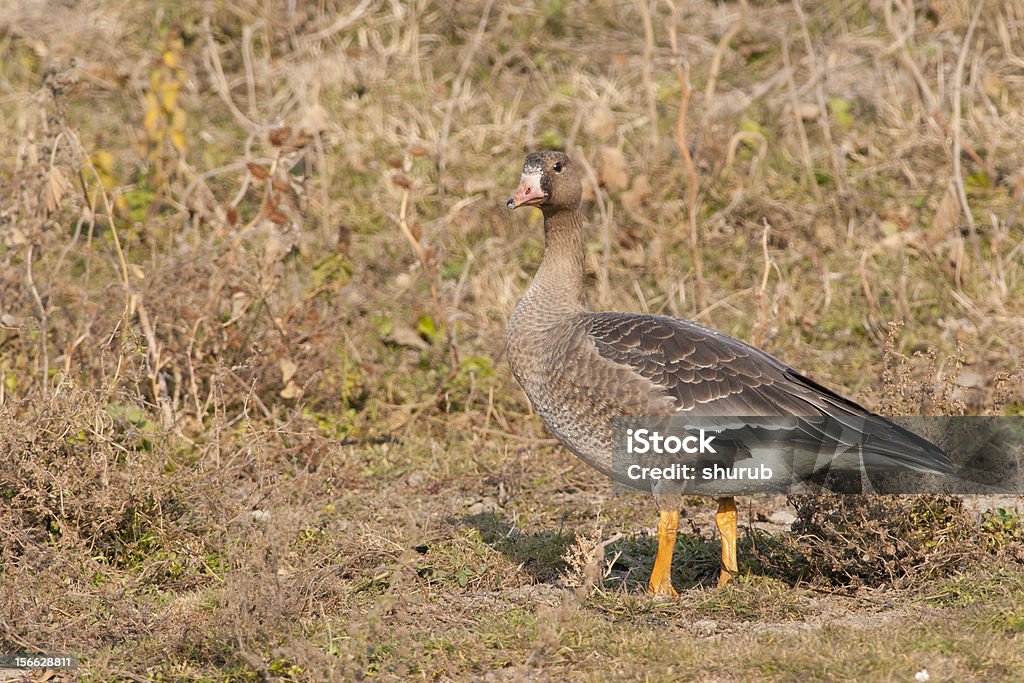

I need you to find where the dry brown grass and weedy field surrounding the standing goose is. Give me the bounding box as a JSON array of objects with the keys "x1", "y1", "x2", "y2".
[{"x1": 0, "y1": 0, "x2": 1024, "y2": 681}]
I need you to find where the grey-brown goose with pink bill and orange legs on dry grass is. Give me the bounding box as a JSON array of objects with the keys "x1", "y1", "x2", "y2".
[{"x1": 505, "y1": 151, "x2": 951, "y2": 596}]
